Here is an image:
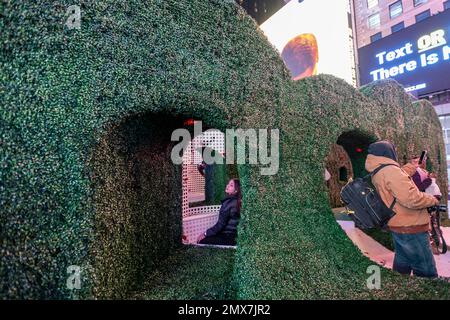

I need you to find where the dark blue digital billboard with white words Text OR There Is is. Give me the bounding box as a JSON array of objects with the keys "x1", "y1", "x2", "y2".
[{"x1": 358, "y1": 10, "x2": 450, "y2": 96}]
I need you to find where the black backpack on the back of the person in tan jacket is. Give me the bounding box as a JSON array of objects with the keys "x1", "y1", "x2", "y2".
[{"x1": 341, "y1": 164, "x2": 397, "y2": 229}]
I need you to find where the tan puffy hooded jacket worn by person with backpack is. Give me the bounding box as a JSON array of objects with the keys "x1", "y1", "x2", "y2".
[{"x1": 366, "y1": 154, "x2": 439, "y2": 233}]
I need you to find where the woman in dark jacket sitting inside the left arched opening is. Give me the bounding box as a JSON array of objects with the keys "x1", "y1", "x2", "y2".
[{"x1": 197, "y1": 179, "x2": 241, "y2": 246}]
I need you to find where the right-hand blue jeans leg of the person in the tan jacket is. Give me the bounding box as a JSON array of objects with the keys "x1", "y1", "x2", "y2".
[{"x1": 411, "y1": 232, "x2": 438, "y2": 278}]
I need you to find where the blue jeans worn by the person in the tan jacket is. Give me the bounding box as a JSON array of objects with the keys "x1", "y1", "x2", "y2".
[{"x1": 392, "y1": 232, "x2": 437, "y2": 278}]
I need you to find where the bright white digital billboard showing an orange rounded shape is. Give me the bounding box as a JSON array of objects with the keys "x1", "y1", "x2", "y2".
[{"x1": 260, "y1": 0, "x2": 356, "y2": 86}]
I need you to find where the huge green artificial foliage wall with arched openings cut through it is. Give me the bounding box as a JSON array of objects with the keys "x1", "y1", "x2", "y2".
[{"x1": 0, "y1": 0, "x2": 450, "y2": 299}]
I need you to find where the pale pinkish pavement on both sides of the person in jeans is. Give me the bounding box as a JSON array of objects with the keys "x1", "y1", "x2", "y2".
[{"x1": 337, "y1": 220, "x2": 450, "y2": 278}]
